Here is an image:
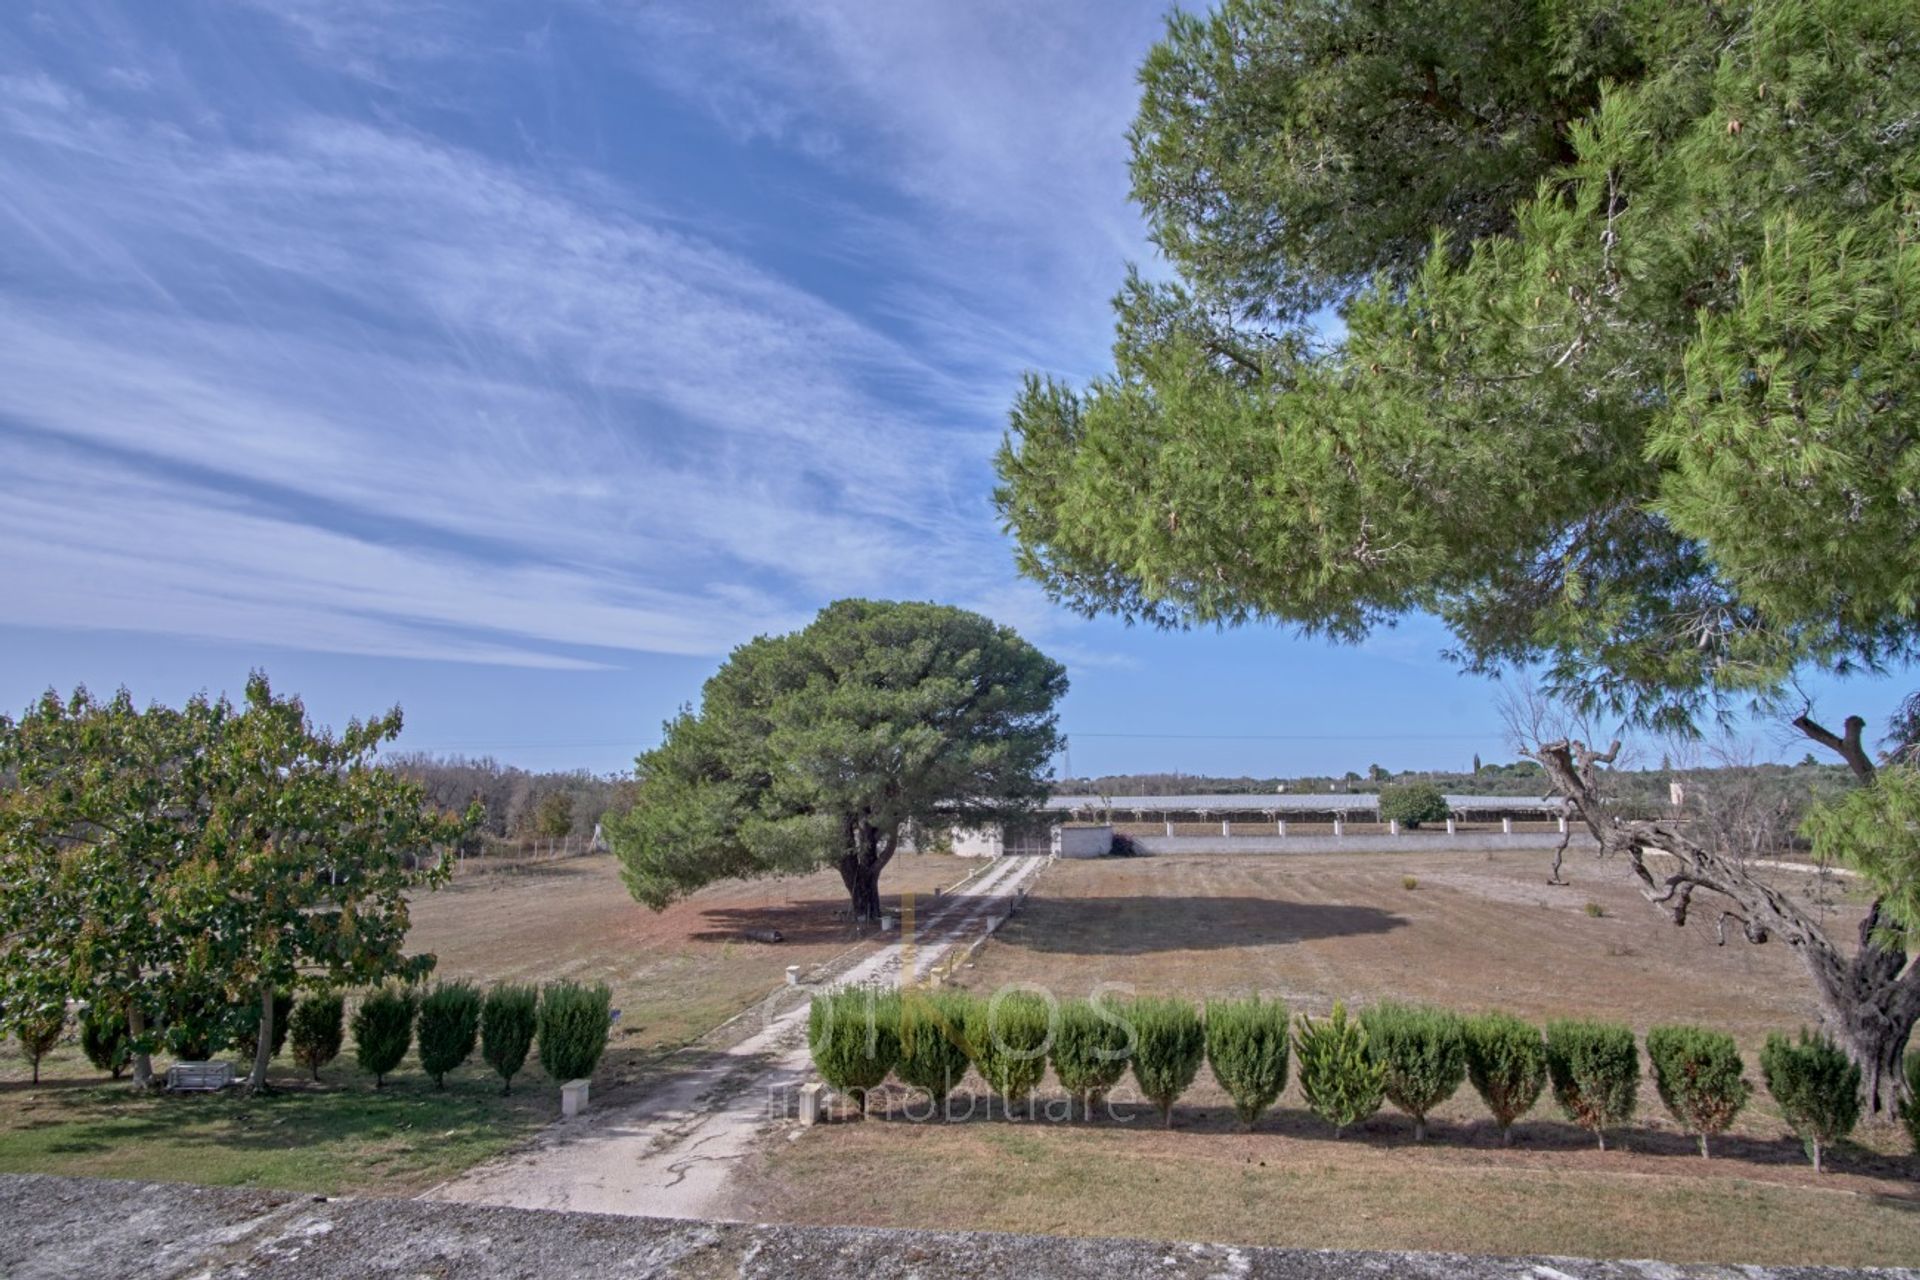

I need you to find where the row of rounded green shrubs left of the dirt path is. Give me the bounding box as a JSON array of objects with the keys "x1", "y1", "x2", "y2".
[{"x1": 15, "y1": 981, "x2": 612, "y2": 1094}]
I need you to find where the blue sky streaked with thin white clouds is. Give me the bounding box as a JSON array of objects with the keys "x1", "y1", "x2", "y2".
[{"x1": 0, "y1": 0, "x2": 1905, "y2": 773}]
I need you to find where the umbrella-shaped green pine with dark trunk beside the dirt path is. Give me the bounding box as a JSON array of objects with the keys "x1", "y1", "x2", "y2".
[{"x1": 607, "y1": 601, "x2": 1066, "y2": 919}]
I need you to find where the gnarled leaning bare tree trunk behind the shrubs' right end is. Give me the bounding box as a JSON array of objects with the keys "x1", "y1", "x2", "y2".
[{"x1": 1536, "y1": 736, "x2": 1920, "y2": 1117}]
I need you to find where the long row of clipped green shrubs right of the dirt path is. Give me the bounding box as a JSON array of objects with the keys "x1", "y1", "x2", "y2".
[{"x1": 808, "y1": 988, "x2": 1920, "y2": 1169}]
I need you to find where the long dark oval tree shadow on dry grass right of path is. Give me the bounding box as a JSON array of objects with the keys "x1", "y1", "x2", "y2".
[{"x1": 1004, "y1": 896, "x2": 1407, "y2": 956}]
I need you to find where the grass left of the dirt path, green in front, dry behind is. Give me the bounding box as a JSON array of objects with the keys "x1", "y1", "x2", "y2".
[{"x1": 0, "y1": 854, "x2": 960, "y2": 1194}]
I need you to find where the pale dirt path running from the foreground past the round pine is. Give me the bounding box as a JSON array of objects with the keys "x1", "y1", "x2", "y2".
[{"x1": 422, "y1": 858, "x2": 1046, "y2": 1217}]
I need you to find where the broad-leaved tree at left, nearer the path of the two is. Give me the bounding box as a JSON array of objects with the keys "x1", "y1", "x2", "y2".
[{"x1": 205, "y1": 672, "x2": 474, "y2": 1090}]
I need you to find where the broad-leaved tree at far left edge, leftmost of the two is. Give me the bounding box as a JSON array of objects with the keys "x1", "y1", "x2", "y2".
[{"x1": 0, "y1": 689, "x2": 227, "y2": 1088}]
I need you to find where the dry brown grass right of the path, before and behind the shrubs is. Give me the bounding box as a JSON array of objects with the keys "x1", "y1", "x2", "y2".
[{"x1": 739, "y1": 854, "x2": 1920, "y2": 1265}]
